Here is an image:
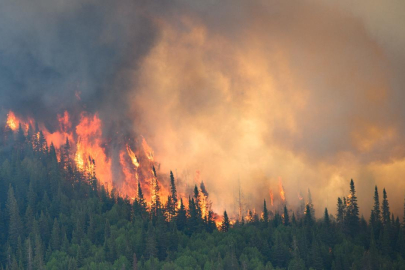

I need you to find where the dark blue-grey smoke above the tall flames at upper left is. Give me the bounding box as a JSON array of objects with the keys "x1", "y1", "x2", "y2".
[{"x1": 0, "y1": 0, "x2": 157, "y2": 133}]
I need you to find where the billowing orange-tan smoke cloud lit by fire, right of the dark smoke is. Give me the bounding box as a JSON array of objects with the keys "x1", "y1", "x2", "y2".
[{"x1": 132, "y1": 1, "x2": 405, "y2": 216}]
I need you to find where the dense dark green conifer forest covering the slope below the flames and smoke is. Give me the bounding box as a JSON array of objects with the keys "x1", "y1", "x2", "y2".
[{"x1": 0, "y1": 127, "x2": 405, "y2": 270}]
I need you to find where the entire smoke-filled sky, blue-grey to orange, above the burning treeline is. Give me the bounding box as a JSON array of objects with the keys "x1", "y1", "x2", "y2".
[{"x1": 0, "y1": 0, "x2": 405, "y2": 216}]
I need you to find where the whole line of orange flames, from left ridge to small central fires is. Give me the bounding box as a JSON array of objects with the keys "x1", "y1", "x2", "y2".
[{"x1": 6, "y1": 111, "x2": 220, "y2": 222}]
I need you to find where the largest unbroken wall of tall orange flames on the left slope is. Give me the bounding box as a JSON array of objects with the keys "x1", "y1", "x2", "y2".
[{"x1": 6, "y1": 111, "x2": 168, "y2": 205}]
